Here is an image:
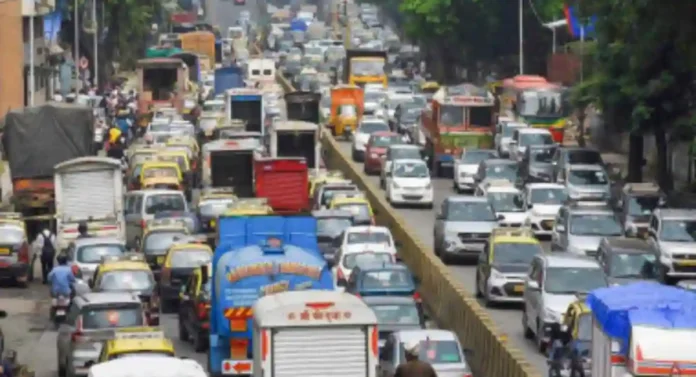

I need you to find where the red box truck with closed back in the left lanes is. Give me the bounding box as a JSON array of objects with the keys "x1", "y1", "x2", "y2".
[{"x1": 254, "y1": 157, "x2": 310, "y2": 213}]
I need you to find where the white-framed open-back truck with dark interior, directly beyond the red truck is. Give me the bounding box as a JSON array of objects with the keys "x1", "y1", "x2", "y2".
[{"x1": 271, "y1": 120, "x2": 319, "y2": 169}]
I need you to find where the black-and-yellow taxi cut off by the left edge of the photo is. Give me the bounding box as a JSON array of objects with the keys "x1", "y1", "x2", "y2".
[{"x1": 0, "y1": 212, "x2": 34, "y2": 287}]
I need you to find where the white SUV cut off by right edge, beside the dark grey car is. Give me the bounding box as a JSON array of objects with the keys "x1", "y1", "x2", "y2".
[{"x1": 648, "y1": 208, "x2": 696, "y2": 283}]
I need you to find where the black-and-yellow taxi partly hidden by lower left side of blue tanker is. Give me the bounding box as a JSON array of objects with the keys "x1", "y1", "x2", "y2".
[{"x1": 178, "y1": 263, "x2": 212, "y2": 352}]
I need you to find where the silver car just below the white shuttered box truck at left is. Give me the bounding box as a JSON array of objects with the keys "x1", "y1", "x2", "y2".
[{"x1": 68, "y1": 237, "x2": 126, "y2": 283}]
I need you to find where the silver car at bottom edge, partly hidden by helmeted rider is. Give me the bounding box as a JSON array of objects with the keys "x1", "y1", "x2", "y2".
[{"x1": 378, "y1": 329, "x2": 471, "y2": 377}]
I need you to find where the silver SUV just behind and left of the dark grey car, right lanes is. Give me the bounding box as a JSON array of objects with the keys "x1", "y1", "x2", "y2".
[{"x1": 551, "y1": 202, "x2": 624, "y2": 256}]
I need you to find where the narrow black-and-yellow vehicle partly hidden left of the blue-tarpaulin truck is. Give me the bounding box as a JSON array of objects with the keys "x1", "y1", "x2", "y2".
[{"x1": 561, "y1": 295, "x2": 592, "y2": 376}]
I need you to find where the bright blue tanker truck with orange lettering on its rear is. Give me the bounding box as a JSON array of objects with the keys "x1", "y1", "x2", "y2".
[{"x1": 208, "y1": 216, "x2": 335, "y2": 377}]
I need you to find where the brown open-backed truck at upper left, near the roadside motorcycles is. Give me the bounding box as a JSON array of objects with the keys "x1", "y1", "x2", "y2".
[{"x1": 138, "y1": 58, "x2": 186, "y2": 111}]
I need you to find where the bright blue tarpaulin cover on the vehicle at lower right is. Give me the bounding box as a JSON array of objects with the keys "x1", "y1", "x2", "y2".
[{"x1": 586, "y1": 282, "x2": 696, "y2": 351}]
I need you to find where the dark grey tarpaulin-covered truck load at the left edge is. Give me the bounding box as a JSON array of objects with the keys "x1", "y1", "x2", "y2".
[{"x1": 2, "y1": 104, "x2": 94, "y2": 179}]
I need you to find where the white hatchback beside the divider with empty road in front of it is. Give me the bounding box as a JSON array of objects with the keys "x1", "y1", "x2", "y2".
[{"x1": 386, "y1": 159, "x2": 434, "y2": 208}]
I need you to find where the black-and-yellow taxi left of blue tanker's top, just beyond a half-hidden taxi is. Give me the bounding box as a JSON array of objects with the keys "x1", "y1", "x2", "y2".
[{"x1": 156, "y1": 237, "x2": 213, "y2": 312}]
